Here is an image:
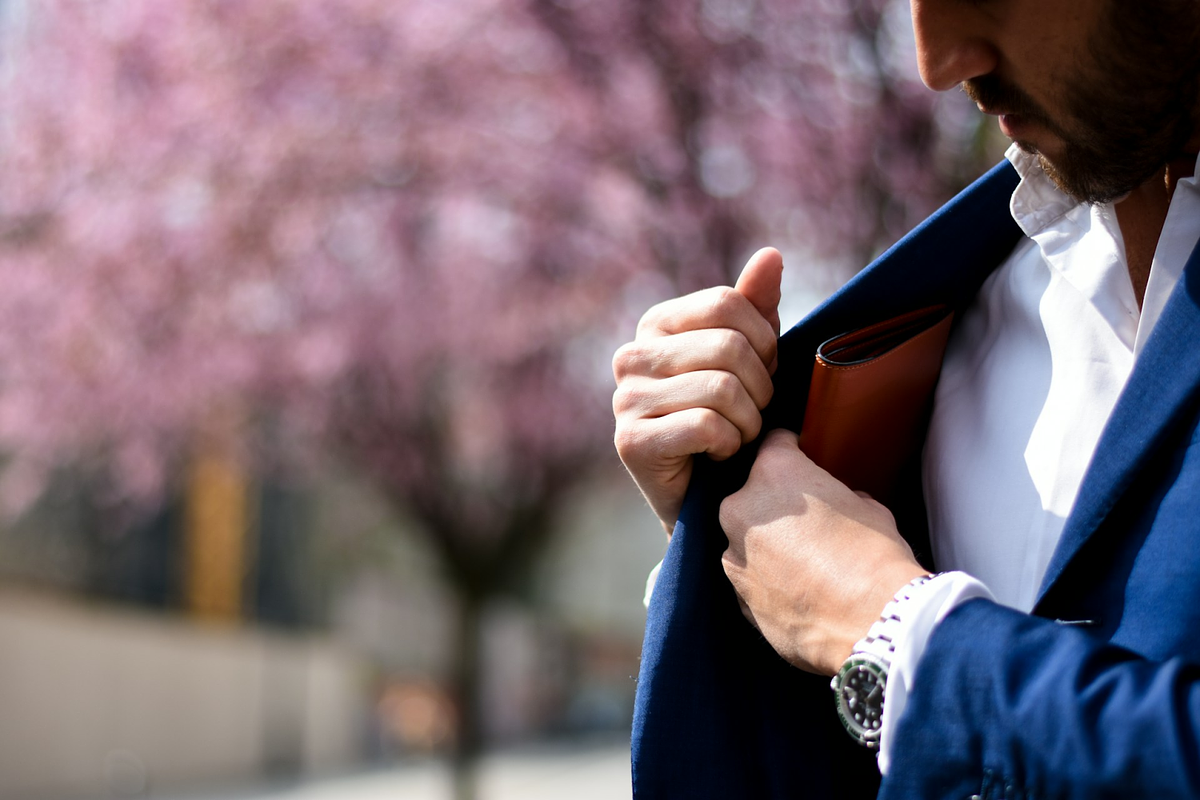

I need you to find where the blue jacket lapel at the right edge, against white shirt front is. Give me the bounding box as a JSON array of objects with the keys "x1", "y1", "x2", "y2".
[{"x1": 1038, "y1": 237, "x2": 1200, "y2": 603}]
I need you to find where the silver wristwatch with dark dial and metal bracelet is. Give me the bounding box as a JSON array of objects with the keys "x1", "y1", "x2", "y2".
[{"x1": 829, "y1": 575, "x2": 934, "y2": 750}]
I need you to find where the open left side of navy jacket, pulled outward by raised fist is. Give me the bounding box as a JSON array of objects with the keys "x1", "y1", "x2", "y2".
[{"x1": 632, "y1": 163, "x2": 1020, "y2": 800}]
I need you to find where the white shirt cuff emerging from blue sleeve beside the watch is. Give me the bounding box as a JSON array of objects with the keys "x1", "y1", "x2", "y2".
[{"x1": 878, "y1": 572, "x2": 992, "y2": 775}]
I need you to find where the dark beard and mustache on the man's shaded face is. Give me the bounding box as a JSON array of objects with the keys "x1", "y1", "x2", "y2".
[{"x1": 962, "y1": 0, "x2": 1200, "y2": 203}]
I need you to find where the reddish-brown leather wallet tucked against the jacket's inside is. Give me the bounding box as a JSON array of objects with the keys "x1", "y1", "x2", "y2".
[{"x1": 800, "y1": 306, "x2": 954, "y2": 505}]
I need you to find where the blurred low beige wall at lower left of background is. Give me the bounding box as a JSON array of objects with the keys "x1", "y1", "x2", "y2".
[{"x1": 0, "y1": 589, "x2": 365, "y2": 798}]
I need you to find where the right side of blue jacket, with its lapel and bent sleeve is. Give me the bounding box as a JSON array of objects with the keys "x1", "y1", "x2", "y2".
[{"x1": 881, "y1": 220, "x2": 1200, "y2": 800}]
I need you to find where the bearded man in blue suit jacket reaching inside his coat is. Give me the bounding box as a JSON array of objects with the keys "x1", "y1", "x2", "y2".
[{"x1": 613, "y1": 0, "x2": 1200, "y2": 799}]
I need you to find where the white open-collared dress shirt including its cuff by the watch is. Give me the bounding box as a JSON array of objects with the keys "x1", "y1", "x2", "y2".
[{"x1": 880, "y1": 146, "x2": 1200, "y2": 772}]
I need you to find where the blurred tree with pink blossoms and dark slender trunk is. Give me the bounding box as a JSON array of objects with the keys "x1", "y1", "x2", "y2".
[{"x1": 0, "y1": 0, "x2": 973, "y2": 796}]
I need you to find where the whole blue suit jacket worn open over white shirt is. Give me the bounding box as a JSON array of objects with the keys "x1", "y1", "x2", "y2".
[{"x1": 634, "y1": 163, "x2": 1200, "y2": 800}]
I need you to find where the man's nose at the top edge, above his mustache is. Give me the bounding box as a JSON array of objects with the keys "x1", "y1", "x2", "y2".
[{"x1": 911, "y1": 0, "x2": 1000, "y2": 91}]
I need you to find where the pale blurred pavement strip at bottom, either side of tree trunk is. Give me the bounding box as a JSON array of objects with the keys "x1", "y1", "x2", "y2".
[{"x1": 180, "y1": 745, "x2": 631, "y2": 800}]
